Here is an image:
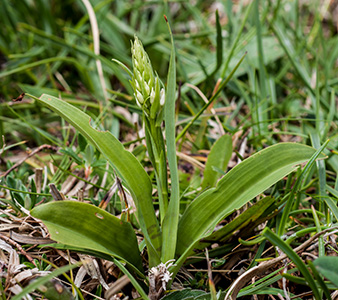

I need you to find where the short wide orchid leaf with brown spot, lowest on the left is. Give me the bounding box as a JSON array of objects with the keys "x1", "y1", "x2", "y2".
[{"x1": 31, "y1": 201, "x2": 142, "y2": 270}]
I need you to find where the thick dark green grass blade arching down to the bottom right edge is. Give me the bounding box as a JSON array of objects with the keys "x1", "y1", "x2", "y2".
[{"x1": 262, "y1": 227, "x2": 322, "y2": 300}]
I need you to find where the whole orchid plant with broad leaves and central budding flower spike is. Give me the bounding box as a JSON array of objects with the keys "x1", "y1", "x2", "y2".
[{"x1": 27, "y1": 19, "x2": 324, "y2": 299}]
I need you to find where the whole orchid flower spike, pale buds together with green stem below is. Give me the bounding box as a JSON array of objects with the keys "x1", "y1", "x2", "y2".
[{"x1": 130, "y1": 36, "x2": 168, "y2": 223}]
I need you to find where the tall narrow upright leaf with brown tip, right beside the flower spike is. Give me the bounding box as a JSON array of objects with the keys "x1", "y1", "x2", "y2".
[{"x1": 162, "y1": 19, "x2": 180, "y2": 262}]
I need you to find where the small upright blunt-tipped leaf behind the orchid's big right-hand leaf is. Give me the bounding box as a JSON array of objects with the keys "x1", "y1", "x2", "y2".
[{"x1": 202, "y1": 134, "x2": 232, "y2": 190}]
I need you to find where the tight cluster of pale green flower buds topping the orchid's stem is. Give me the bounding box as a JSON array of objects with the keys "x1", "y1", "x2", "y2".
[{"x1": 131, "y1": 36, "x2": 165, "y2": 120}]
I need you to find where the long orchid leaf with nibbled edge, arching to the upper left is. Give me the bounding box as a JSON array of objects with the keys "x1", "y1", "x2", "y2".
[{"x1": 28, "y1": 95, "x2": 161, "y2": 266}]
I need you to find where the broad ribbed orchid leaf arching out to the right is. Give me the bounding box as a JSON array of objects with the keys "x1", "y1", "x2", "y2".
[{"x1": 177, "y1": 143, "x2": 323, "y2": 254}]
